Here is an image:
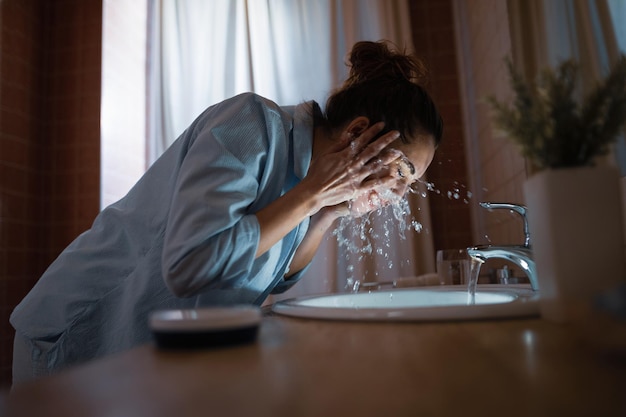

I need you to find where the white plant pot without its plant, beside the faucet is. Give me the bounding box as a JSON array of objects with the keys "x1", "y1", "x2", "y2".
[{"x1": 524, "y1": 166, "x2": 626, "y2": 323}]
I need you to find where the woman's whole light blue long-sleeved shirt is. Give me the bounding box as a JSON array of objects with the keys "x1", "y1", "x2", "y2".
[{"x1": 11, "y1": 93, "x2": 313, "y2": 369}]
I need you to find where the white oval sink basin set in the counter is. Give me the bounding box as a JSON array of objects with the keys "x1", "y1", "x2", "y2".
[{"x1": 272, "y1": 284, "x2": 539, "y2": 321}]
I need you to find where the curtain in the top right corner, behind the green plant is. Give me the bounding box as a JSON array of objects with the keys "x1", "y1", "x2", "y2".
[{"x1": 508, "y1": 0, "x2": 626, "y2": 175}]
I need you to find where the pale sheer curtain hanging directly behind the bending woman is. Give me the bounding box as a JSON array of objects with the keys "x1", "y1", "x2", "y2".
[{"x1": 148, "y1": 0, "x2": 434, "y2": 296}]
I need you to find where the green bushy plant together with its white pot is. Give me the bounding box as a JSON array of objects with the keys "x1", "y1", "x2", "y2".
[{"x1": 488, "y1": 56, "x2": 626, "y2": 322}]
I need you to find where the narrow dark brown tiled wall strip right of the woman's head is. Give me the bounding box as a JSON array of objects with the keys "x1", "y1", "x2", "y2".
[{"x1": 409, "y1": 0, "x2": 475, "y2": 250}]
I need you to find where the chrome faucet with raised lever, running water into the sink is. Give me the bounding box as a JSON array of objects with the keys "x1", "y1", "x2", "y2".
[{"x1": 467, "y1": 202, "x2": 539, "y2": 291}]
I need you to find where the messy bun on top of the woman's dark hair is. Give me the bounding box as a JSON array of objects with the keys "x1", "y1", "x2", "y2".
[{"x1": 344, "y1": 41, "x2": 426, "y2": 86}]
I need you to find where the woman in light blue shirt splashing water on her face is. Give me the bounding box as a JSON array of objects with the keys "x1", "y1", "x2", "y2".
[{"x1": 11, "y1": 42, "x2": 442, "y2": 383}]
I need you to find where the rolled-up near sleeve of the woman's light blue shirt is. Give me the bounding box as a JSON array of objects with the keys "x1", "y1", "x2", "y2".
[{"x1": 162, "y1": 97, "x2": 286, "y2": 297}]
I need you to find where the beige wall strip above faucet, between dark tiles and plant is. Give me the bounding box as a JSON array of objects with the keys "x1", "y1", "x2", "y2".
[{"x1": 454, "y1": 0, "x2": 526, "y2": 250}]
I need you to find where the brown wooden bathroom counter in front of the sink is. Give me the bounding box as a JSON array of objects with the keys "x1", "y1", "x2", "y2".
[{"x1": 0, "y1": 314, "x2": 626, "y2": 417}]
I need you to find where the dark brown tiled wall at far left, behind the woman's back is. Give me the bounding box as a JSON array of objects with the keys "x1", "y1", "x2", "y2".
[{"x1": 0, "y1": 0, "x2": 102, "y2": 387}]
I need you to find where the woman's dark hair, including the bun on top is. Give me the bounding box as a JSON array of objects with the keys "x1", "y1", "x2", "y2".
[{"x1": 316, "y1": 41, "x2": 443, "y2": 146}]
